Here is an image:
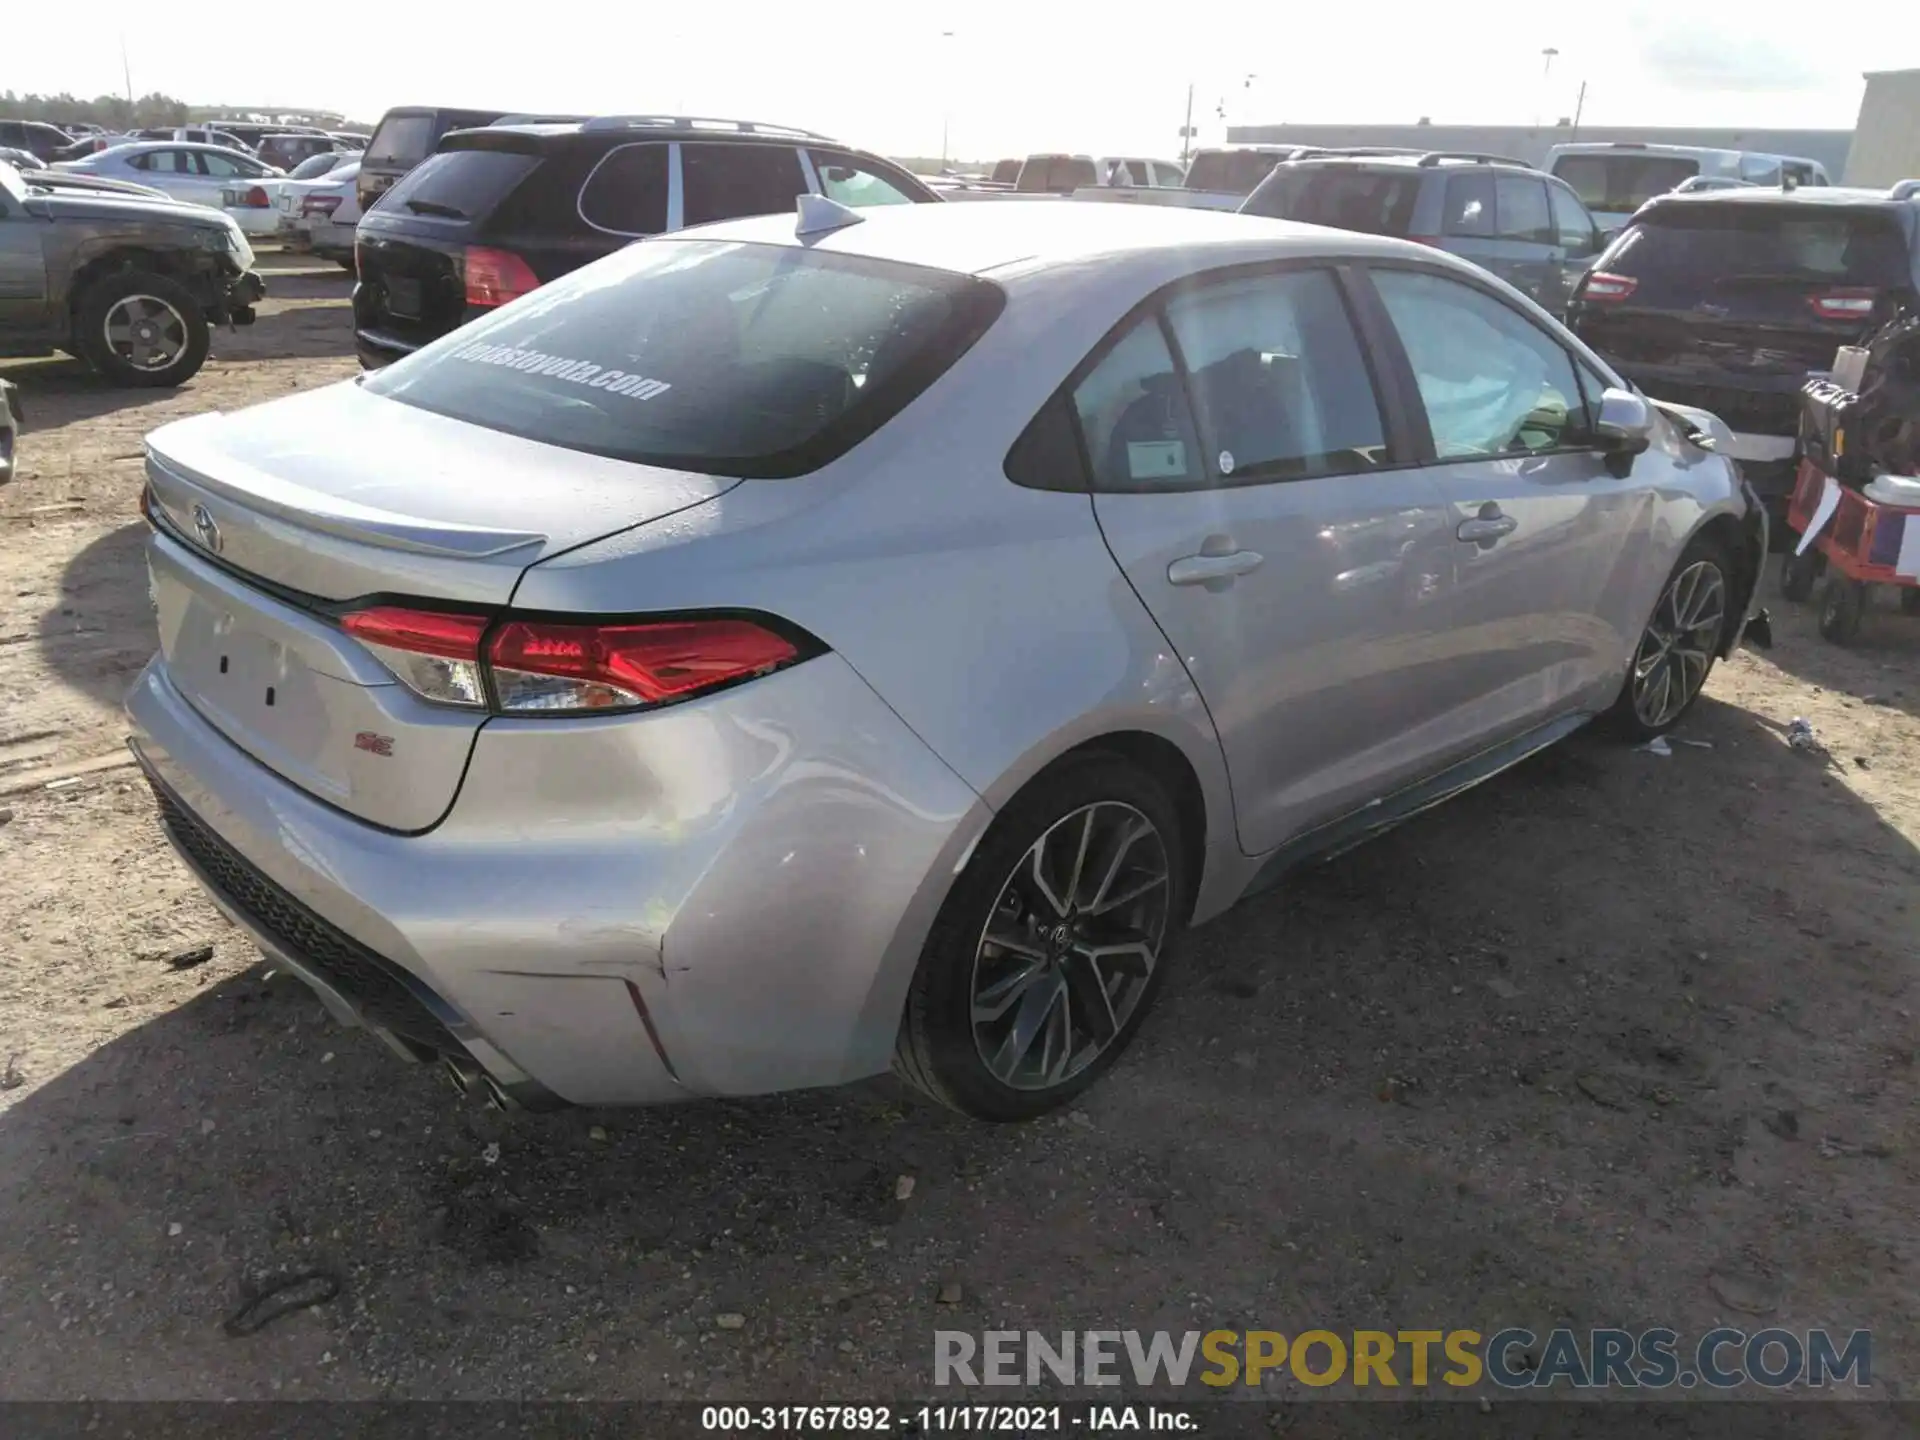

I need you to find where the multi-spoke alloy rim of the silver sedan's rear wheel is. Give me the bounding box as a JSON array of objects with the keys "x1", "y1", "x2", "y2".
[{"x1": 972, "y1": 801, "x2": 1173, "y2": 1091}]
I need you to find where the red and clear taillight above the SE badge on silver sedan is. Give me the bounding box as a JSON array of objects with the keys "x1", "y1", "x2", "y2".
[{"x1": 340, "y1": 605, "x2": 803, "y2": 714}]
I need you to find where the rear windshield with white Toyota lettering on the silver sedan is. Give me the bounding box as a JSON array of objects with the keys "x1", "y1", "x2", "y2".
[{"x1": 363, "y1": 238, "x2": 1002, "y2": 478}]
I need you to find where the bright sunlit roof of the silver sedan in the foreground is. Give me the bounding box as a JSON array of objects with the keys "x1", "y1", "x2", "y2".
[{"x1": 678, "y1": 200, "x2": 1444, "y2": 284}]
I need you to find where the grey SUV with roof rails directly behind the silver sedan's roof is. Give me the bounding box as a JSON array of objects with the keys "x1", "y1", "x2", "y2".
[{"x1": 1240, "y1": 150, "x2": 1607, "y2": 315}]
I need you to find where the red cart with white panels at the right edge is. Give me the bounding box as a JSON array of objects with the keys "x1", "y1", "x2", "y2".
[{"x1": 1780, "y1": 461, "x2": 1920, "y2": 645}]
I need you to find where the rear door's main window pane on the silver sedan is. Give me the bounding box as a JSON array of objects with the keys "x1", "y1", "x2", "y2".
[{"x1": 1167, "y1": 271, "x2": 1386, "y2": 482}]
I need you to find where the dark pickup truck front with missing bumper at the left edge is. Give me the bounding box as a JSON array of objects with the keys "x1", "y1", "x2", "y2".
[{"x1": 0, "y1": 165, "x2": 267, "y2": 386}]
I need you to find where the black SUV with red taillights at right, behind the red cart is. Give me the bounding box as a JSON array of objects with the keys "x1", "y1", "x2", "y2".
[{"x1": 1569, "y1": 182, "x2": 1920, "y2": 520}]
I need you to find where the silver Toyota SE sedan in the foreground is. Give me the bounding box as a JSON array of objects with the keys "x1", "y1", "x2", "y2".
[{"x1": 131, "y1": 198, "x2": 1764, "y2": 1119}]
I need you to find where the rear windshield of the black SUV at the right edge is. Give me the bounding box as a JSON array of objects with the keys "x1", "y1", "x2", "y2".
[{"x1": 1603, "y1": 202, "x2": 1912, "y2": 288}]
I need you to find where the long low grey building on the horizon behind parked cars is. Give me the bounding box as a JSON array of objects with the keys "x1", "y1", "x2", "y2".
[{"x1": 1227, "y1": 121, "x2": 1850, "y2": 175}]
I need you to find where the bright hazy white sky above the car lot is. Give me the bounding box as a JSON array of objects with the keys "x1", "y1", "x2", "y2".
[{"x1": 0, "y1": 0, "x2": 1920, "y2": 159}]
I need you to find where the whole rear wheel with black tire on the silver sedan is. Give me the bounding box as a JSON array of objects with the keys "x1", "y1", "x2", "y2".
[{"x1": 893, "y1": 753, "x2": 1188, "y2": 1121}]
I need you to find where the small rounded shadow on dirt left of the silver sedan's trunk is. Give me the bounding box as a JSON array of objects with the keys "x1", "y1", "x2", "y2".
[{"x1": 38, "y1": 520, "x2": 159, "y2": 718}]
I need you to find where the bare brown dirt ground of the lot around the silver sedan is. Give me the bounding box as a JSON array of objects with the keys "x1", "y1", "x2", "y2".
[{"x1": 0, "y1": 251, "x2": 1920, "y2": 1400}]
